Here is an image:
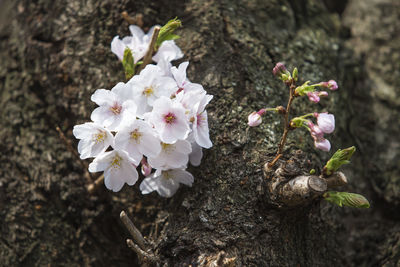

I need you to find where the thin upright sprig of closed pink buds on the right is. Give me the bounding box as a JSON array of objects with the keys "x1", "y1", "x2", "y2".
[{"x1": 248, "y1": 63, "x2": 338, "y2": 154}]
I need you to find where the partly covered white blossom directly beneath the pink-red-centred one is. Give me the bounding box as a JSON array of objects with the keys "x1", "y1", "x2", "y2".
[{"x1": 147, "y1": 140, "x2": 192, "y2": 169}]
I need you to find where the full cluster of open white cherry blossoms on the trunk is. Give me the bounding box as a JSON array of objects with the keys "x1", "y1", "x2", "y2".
[{"x1": 73, "y1": 22, "x2": 213, "y2": 197}]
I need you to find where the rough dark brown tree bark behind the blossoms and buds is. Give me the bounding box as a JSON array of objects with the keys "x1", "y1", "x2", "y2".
[{"x1": 0, "y1": 0, "x2": 400, "y2": 266}]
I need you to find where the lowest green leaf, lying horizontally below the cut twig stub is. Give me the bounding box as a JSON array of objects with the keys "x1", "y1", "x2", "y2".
[{"x1": 323, "y1": 191, "x2": 370, "y2": 209}]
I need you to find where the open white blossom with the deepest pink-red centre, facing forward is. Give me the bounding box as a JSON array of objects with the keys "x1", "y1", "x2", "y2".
[{"x1": 149, "y1": 96, "x2": 190, "y2": 144}]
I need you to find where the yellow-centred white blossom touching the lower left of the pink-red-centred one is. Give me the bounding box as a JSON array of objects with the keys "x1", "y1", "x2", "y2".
[{"x1": 113, "y1": 120, "x2": 161, "y2": 162}]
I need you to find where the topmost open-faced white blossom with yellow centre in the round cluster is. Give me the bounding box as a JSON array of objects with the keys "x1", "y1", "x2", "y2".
[{"x1": 128, "y1": 64, "x2": 177, "y2": 116}]
